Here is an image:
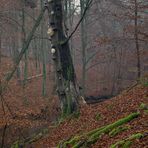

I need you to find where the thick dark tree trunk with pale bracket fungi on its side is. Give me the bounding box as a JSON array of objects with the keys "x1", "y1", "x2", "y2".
[{"x1": 46, "y1": 0, "x2": 79, "y2": 117}]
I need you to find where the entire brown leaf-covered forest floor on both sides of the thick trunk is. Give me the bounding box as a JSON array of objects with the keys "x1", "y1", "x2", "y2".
[{"x1": 0, "y1": 57, "x2": 148, "y2": 148}]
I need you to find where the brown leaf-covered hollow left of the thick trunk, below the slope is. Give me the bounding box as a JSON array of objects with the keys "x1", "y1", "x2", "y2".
[{"x1": 0, "y1": 57, "x2": 57, "y2": 148}]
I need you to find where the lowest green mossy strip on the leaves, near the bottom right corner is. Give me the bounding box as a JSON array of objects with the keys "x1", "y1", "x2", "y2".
[{"x1": 111, "y1": 133, "x2": 143, "y2": 148}]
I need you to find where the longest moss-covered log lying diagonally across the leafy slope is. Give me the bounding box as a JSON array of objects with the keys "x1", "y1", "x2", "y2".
[{"x1": 58, "y1": 112, "x2": 140, "y2": 148}]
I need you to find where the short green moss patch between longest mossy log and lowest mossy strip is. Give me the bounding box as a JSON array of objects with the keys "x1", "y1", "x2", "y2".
[{"x1": 109, "y1": 126, "x2": 129, "y2": 137}]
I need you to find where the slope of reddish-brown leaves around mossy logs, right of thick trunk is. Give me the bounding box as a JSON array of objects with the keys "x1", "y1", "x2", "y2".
[{"x1": 32, "y1": 85, "x2": 148, "y2": 148}]
